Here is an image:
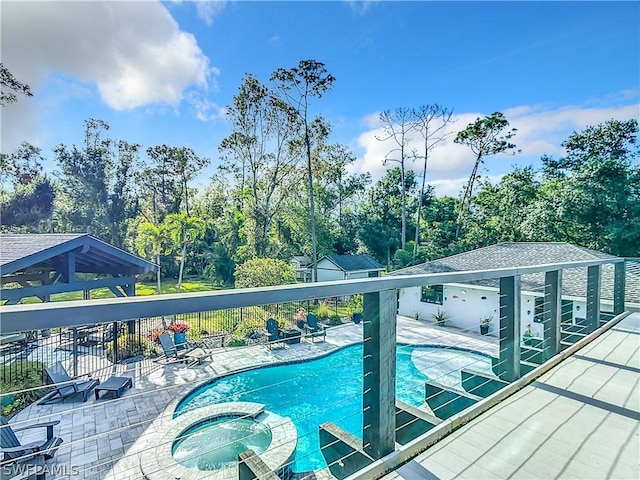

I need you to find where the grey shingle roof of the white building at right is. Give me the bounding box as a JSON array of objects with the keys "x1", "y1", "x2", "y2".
[{"x1": 390, "y1": 242, "x2": 640, "y2": 303}]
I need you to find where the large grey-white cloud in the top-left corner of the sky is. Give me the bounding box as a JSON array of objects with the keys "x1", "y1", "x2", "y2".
[{"x1": 2, "y1": 1, "x2": 212, "y2": 110}]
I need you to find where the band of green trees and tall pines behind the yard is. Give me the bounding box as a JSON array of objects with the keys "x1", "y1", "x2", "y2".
[{"x1": 0, "y1": 61, "x2": 640, "y2": 291}]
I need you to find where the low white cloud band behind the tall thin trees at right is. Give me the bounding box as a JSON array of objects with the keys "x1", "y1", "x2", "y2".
[{"x1": 352, "y1": 103, "x2": 640, "y2": 196}]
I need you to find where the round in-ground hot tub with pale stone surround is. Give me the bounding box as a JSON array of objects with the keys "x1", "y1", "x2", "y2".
[{"x1": 140, "y1": 402, "x2": 298, "y2": 480}]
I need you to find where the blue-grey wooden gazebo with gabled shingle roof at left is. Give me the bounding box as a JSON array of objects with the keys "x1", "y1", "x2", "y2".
[{"x1": 0, "y1": 233, "x2": 159, "y2": 305}]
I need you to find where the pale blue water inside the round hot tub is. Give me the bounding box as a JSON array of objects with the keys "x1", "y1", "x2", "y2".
[{"x1": 173, "y1": 417, "x2": 271, "y2": 471}]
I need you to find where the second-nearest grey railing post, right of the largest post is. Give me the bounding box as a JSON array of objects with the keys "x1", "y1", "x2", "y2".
[{"x1": 497, "y1": 276, "x2": 521, "y2": 382}]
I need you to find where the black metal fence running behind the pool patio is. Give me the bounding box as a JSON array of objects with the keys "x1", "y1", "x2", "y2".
[{"x1": 0, "y1": 298, "x2": 348, "y2": 386}]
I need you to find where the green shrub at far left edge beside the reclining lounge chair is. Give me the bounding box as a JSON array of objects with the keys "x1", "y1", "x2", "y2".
[{"x1": 0, "y1": 361, "x2": 45, "y2": 417}]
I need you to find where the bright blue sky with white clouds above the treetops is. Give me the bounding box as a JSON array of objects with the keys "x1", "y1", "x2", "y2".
[{"x1": 1, "y1": 0, "x2": 640, "y2": 194}]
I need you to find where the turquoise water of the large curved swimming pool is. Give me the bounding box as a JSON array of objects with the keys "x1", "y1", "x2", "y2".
[{"x1": 176, "y1": 344, "x2": 491, "y2": 472}]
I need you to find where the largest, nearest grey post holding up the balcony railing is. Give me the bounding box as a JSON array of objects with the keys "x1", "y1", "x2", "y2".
[{"x1": 362, "y1": 290, "x2": 397, "y2": 459}]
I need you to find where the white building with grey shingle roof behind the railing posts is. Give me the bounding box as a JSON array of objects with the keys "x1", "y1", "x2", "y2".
[{"x1": 390, "y1": 242, "x2": 640, "y2": 337}]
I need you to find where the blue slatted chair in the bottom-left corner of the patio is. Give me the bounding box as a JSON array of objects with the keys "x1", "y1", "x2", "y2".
[{"x1": 0, "y1": 416, "x2": 62, "y2": 469}]
